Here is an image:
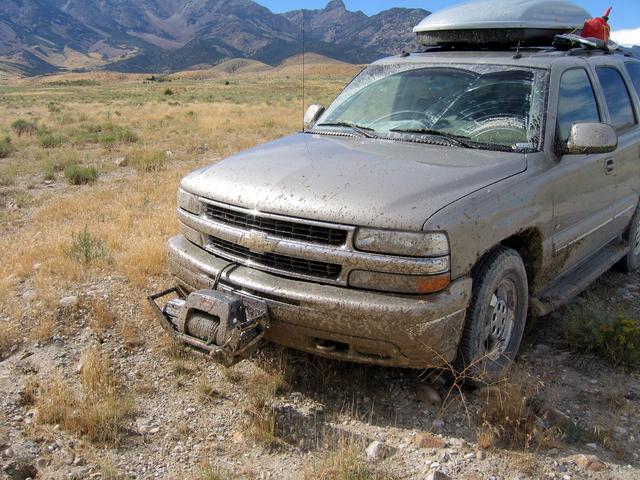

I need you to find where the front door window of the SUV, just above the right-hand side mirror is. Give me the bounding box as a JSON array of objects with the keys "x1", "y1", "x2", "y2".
[{"x1": 558, "y1": 68, "x2": 601, "y2": 142}]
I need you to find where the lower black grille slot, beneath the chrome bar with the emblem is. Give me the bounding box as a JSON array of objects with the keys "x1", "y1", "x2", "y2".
[{"x1": 209, "y1": 236, "x2": 342, "y2": 279}]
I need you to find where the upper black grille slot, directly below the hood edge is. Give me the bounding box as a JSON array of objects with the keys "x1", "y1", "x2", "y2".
[{"x1": 206, "y1": 204, "x2": 347, "y2": 245}]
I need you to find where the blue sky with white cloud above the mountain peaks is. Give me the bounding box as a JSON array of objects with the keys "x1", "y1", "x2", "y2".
[{"x1": 257, "y1": 0, "x2": 640, "y2": 45}]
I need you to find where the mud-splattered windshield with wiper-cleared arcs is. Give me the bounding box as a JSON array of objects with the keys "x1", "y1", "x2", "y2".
[{"x1": 312, "y1": 64, "x2": 547, "y2": 149}]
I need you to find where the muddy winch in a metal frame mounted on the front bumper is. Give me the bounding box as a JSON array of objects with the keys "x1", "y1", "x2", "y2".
[{"x1": 148, "y1": 287, "x2": 269, "y2": 367}]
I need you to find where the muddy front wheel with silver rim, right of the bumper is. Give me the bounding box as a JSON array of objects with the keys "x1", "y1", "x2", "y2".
[{"x1": 456, "y1": 247, "x2": 529, "y2": 385}]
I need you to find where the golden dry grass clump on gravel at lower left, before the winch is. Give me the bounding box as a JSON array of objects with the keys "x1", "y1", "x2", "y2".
[{"x1": 35, "y1": 349, "x2": 133, "y2": 444}]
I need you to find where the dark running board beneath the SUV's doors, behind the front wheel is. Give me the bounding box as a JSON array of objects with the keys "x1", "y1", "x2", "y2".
[{"x1": 531, "y1": 241, "x2": 629, "y2": 317}]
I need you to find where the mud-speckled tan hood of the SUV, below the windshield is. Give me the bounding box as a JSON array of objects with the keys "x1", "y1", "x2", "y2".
[{"x1": 182, "y1": 133, "x2": 527, "y2": 230}]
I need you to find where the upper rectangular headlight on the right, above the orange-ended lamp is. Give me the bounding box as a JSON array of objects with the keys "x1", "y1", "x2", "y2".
[{"x1": 354, "y1": 228, "x2": 449, "y2": 257}]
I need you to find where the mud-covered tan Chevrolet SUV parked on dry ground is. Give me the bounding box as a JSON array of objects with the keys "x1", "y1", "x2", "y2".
[{"x1": 158, "y1": 48, "x2": 640, "y2": 375}]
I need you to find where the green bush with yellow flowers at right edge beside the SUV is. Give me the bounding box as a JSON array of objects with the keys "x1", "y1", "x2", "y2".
[{"x1": 559, "y1": 298, "x2": 640, "y2": 367}]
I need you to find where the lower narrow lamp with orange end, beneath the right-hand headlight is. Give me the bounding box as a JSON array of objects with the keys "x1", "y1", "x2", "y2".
[{"x1": 349, "y1": 270, "x2": 450, "y2": 294}]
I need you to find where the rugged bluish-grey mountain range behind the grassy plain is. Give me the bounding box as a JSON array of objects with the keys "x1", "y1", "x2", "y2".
[{"x1": 0, "y1": 0, "x2": 430, "y2": 75}]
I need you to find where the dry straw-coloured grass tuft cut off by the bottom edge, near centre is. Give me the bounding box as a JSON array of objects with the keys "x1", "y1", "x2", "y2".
[{"x1": 303, "y1": 438, "x2": 394, "y2": 480}]
